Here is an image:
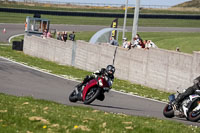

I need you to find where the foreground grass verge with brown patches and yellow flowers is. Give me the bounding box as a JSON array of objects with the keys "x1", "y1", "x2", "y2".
[{"x1": 0, "y1": 93, "x2": 200, "y2": 133}]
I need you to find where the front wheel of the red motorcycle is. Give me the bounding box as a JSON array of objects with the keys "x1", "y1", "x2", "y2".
[{"x1": 83, "y1": 87, "x2": 100, "y2": 104}]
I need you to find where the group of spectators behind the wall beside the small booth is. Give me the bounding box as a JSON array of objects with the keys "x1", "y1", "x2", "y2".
[{"x1": 42, "y1": 30, "x2": 75, "y2": 42}]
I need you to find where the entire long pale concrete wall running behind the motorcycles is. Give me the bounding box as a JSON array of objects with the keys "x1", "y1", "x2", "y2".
[{"x1": 23, "y1": 36, "x2": 200, "y2": 92}]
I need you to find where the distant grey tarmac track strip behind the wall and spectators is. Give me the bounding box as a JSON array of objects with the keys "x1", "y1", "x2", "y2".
[{"x1": 0, "y1": 23, "x2": 200, "y2": 42}]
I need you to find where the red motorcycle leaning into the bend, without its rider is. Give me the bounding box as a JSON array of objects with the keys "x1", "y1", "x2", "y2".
[{"x1": 69, "y1": 76, "x2": 111, "y2": 104}]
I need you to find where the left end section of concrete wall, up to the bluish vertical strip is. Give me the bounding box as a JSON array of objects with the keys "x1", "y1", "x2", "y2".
[{"x1": 23, "y1": 36, "x2": 73, "y2": 65}]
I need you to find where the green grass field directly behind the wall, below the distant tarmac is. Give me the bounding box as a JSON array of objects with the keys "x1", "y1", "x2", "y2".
[{"x1": 76, "y1": 32, "x2": 200, "y2": 54}]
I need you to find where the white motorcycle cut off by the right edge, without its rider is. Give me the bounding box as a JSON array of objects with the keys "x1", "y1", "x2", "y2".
[{"x1": 163, "y1": 90, "x2": 200, "y2": 122}]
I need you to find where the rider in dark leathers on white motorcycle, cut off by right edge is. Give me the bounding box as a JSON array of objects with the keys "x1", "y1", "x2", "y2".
[{"x1": 172, "y1": 76, "x2": 200, "y2": 110}]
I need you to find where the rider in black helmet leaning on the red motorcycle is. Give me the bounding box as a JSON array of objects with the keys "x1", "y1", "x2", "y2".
[{"x1": 77, "y1": 65, "x2": 115, "y2": 92}]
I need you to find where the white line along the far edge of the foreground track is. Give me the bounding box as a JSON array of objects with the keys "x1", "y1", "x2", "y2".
[{"x1": 0, "y1": 56, "x2": 166, "y2": 104}]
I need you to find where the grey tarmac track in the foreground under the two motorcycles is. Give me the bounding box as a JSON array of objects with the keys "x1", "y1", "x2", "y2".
[{"x1": 0, "y1": 57, "x2": 200, "y2": 126}]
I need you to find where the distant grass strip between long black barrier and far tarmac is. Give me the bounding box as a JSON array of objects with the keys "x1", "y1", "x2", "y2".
[{"x1": 0, "y1": 12, "x2": 200, "y2": 27}]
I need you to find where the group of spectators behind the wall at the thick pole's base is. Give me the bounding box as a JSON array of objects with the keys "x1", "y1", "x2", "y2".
[{"x1": 122, "y1": 34, "x2": 157, "y2": 49}]
